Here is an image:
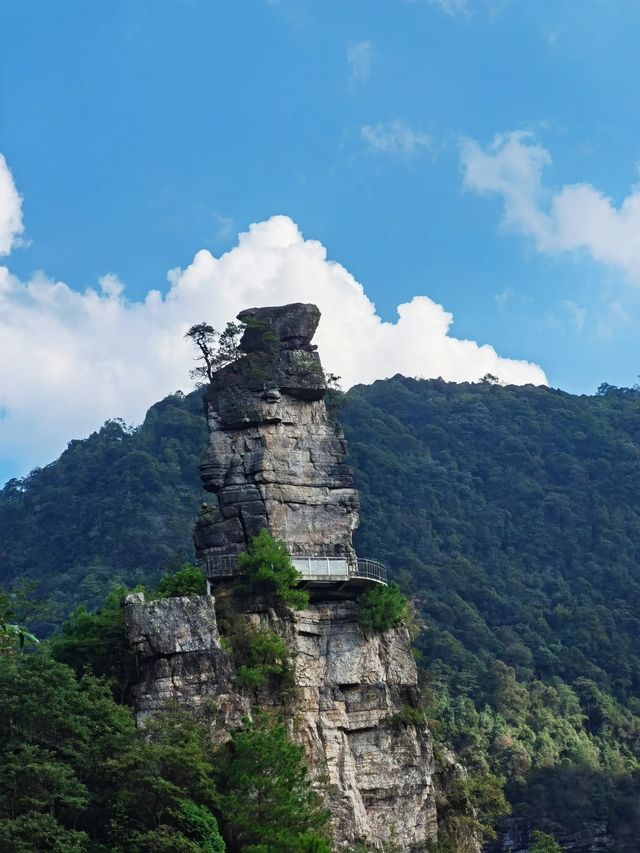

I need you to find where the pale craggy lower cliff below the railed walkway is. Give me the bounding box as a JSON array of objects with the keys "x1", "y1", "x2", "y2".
[{"x1": 125, "y1": 594, "x2": 437, "y2": 851}]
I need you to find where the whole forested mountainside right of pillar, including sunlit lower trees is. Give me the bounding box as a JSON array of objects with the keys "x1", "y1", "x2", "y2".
[{"x1": 343, "y1": 377, "x2": 640, "y2": 853}]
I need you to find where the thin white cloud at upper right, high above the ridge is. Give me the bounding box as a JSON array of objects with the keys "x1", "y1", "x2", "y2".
[{"x1": 461, "y1": 131, "x2": 640, "y2": 284}]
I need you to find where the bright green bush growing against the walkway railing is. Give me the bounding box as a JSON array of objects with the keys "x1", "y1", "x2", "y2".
[{"x1": 238, "y1": 529, "x2": 309, "y2": 610}]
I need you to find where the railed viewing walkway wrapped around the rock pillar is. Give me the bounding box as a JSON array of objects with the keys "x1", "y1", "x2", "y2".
[{"x1": 196, "y1": 555, "x2": 387, "y2": 591}]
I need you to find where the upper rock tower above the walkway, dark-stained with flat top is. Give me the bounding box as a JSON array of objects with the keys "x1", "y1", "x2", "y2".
[{"x1": 194, "y1": 303, "x2": 359, "y2": 561}]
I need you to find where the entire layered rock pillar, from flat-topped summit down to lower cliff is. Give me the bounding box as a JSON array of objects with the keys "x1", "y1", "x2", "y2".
[{"x1": 125, "y1": 304, "x2": 476, "y2": 851}]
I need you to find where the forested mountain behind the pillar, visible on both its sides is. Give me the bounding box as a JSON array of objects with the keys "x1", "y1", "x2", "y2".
[{"x1": 0, "y1": 377, "x2": 640, "y2": 851}]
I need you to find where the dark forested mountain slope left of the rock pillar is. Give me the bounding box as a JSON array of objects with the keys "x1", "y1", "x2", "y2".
[{"x1": 0, "y1": 391, "x2": 207, "y2": 637}]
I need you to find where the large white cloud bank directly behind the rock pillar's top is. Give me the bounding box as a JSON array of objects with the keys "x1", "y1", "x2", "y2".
[{"x1": 0, "y1": 216, "x2": 546, "y2": 470}]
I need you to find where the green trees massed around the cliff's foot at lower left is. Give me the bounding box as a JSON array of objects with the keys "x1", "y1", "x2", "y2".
[{"x1": 0, "y1": 584, "x2": 330, "y2": 853}]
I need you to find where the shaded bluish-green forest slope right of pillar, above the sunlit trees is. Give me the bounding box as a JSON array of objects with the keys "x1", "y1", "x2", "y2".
[{"x1": 343, "y1": 378, "x2": 640, "y2": 699}]
